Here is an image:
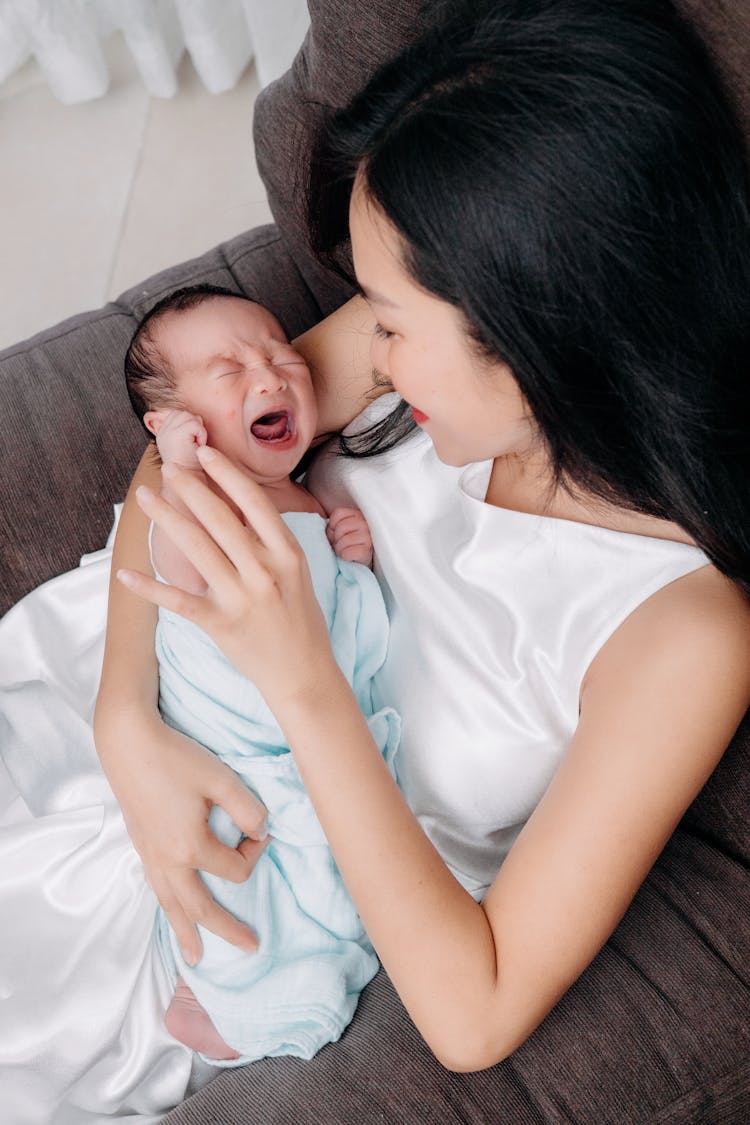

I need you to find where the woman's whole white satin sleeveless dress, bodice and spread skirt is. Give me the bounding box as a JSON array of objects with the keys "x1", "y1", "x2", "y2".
[{"x1": 0, "y1": 399, "x2": 706, "y2": 1125}]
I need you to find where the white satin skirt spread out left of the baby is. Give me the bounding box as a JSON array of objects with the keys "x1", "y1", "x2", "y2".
[{"x1": 0, "y1": 522, "x2": 214, "y2": 1125}]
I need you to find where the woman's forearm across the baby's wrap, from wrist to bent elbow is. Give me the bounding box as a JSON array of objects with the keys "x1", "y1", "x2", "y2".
[{"x1": 270, "y1": 669, "x2": 503, "y2": 1070}]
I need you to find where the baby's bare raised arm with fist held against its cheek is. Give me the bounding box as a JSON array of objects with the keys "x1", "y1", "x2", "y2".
[{"x1": 146, "y1": 410, "x2": 207, "y2": 594}]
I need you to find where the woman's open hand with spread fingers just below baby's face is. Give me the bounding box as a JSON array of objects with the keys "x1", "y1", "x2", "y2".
[{"x1": 117, "y1": 447, "x2": 334, "y2": 718}]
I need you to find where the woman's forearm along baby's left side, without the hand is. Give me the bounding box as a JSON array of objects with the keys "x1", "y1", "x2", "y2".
[{"x1": 94, "y1": 448, "x2": 161, "y2": 754}]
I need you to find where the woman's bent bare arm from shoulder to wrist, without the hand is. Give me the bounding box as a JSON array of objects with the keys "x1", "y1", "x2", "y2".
[{"x1": 244, "y1": 567, "x2": 750, "y2": 1071}]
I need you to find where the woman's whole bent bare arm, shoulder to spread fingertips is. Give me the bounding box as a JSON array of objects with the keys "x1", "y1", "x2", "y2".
[{"x1": 120, "y1": 452, "x2": 750, "y2": 1070}]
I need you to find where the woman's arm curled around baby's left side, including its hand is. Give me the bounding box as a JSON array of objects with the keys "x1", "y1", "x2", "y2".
[{"x1": 94, "y1": 447, "x2": 264, "y2": 963}]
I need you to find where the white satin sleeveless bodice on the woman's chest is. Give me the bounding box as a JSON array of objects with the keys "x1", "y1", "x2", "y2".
[{"x1": 308, "y1": 395, "x2": 707, "y2": 899}]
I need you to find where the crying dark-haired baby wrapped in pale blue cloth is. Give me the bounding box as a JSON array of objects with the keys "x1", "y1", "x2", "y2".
[{"x1": 125, "y1": 286, "x2": 399, "y2": 1065}]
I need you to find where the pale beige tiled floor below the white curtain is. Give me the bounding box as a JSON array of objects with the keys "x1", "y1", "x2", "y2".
[{"x1": 0, "y1": 34, "x2": 270, "y2": 348}]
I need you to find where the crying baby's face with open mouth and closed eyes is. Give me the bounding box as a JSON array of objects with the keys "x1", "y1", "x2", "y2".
[{"x1": 156, "y1": 297, "x2": 317, "y2": 484}]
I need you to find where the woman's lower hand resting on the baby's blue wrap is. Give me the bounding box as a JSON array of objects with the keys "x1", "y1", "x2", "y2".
[{"x1": 98, "y1": 713, "x2": 268, "y2": 964}]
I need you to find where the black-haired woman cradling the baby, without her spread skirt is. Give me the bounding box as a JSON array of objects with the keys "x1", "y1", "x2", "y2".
[{"x1": 98, "y1": 0, "x2": 750, "y2": 1089}]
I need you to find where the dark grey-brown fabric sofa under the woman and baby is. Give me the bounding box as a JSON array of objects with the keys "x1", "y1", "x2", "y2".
[{"x1": 0, "y1": 0, "x2": 750, "y2": 1125}]
